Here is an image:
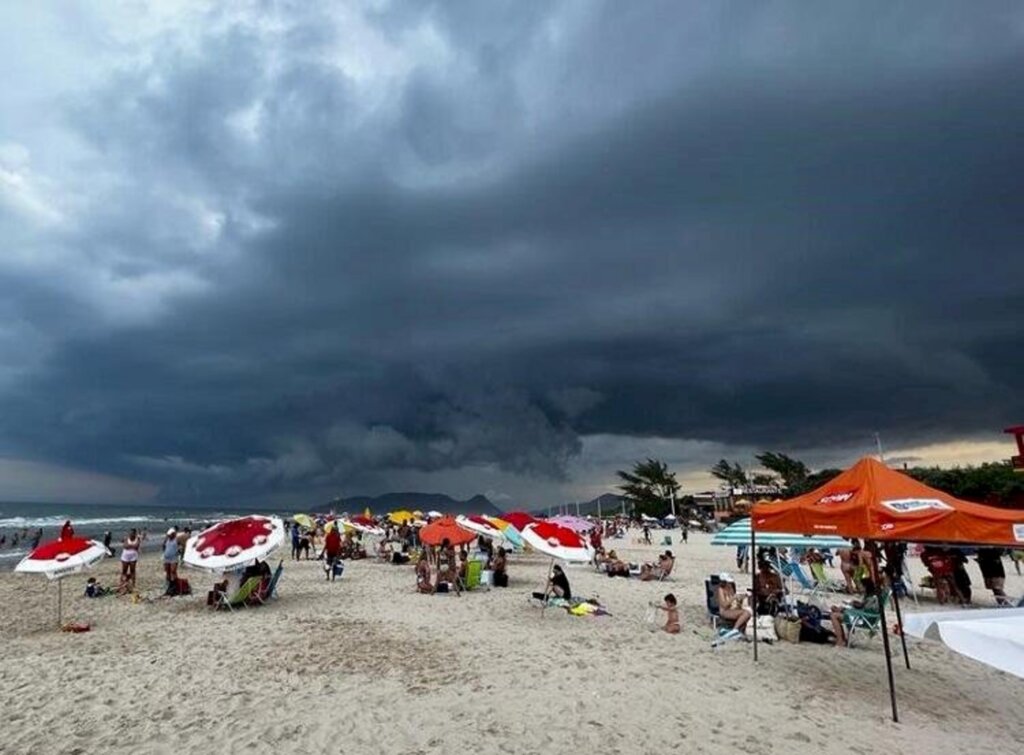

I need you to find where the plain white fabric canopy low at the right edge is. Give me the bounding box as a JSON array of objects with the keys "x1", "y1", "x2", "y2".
[{"x1": 903, "y1": 609, "x2": 1024, "y2": 678}]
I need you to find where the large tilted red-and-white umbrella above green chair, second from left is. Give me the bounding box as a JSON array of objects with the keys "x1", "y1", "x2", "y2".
[{"x1": 184, "y1": 515, "x2": 285, "y2": 573}]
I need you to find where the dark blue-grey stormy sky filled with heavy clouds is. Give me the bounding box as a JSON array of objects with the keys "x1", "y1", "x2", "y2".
[{"x1": 0, "y1": 0, "x2": 1024, "y2": 505}]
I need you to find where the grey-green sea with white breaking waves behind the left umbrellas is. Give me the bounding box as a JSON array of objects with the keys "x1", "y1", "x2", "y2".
[{"x1": 0, "y1": 502, "x2": 280, "y2": 571}]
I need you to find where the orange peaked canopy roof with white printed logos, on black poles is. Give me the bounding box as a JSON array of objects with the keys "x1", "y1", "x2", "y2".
[{"x1": 752, "y1": 458, "x2": 1024, "y2": 547}]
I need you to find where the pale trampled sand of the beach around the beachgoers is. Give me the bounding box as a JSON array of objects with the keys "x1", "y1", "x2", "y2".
[{"x1": 0, "y1": 535, "x2": 1024, "y2": 755}]
